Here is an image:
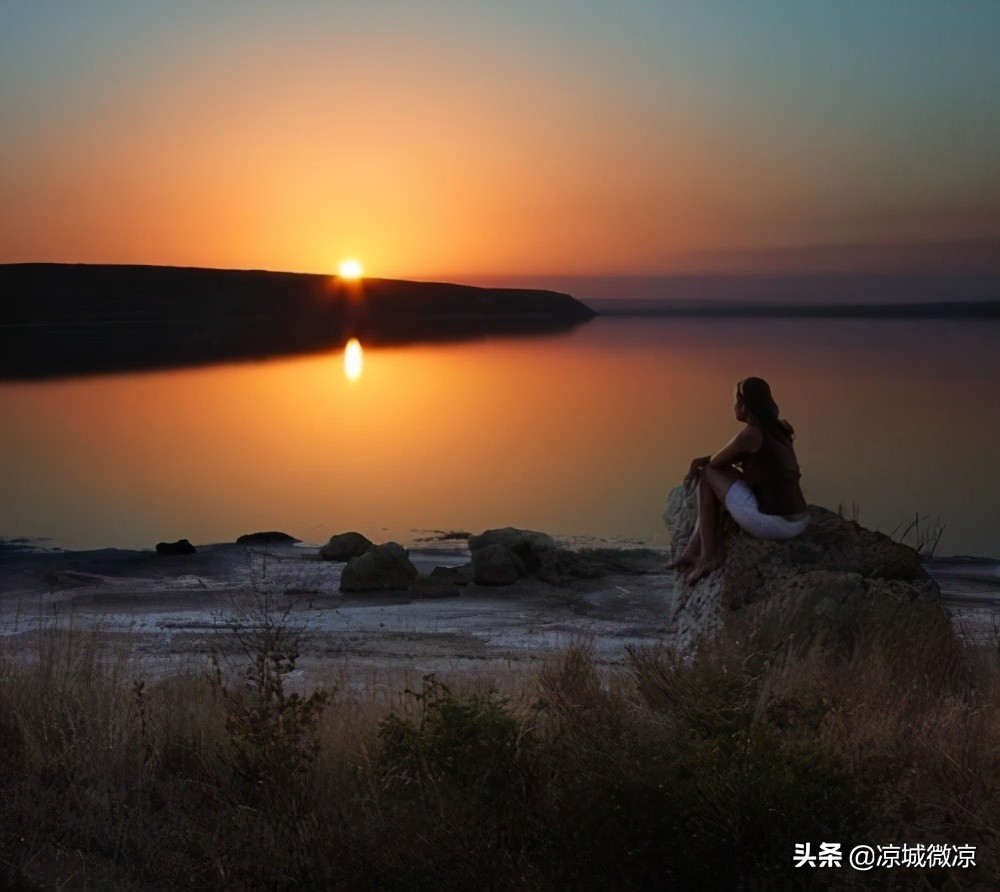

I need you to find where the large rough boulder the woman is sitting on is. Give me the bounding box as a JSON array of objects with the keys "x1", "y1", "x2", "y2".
[{"x1": 663, "y1": 484, "x2": 948, "y2": 650}]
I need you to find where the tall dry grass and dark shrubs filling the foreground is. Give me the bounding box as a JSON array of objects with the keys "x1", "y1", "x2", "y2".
[{"x1": 0, "y1": 609, "x2": 1000, "y2": 889}]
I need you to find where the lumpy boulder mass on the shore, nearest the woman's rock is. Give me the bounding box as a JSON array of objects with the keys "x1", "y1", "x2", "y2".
[{"x1": 469, "y1": 527, "x2": 604, "y2": 585}]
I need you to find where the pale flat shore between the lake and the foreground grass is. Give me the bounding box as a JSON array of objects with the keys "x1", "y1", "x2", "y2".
[{"x1": 0, "y1": 544, "x2": 1000, "y2": 684}]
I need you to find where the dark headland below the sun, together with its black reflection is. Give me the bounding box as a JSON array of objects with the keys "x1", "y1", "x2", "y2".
[{"x1": 0, "y1": 263, "x2": 595, "y2": 379}]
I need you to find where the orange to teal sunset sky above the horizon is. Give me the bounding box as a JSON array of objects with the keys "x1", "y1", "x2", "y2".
[{"x1": 0, "y1": 0, "x2": 1000, "y2": 280}]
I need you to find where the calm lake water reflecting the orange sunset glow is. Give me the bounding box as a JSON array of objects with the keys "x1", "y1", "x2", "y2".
[{"x1": 0, "y1": 319, "x2": 1000, "y2": 557}]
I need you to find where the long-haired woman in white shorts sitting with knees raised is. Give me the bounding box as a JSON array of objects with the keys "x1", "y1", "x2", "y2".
[{"x1": 670, "y1": 378, "x2": 809, "y2": 585}]
